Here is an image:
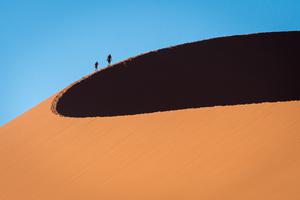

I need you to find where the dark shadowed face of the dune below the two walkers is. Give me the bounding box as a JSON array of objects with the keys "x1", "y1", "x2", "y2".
[{"x1": 56, "y1": 32, "x2": 300, "y2": 117}]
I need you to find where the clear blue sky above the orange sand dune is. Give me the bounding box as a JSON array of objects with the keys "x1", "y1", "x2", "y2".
[{"x1": 0, "y1": 0, "x2": 300, "y2": 125}]
